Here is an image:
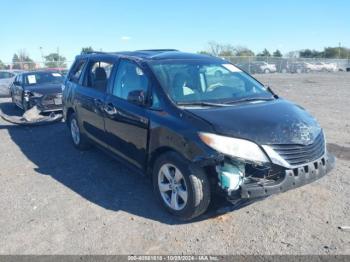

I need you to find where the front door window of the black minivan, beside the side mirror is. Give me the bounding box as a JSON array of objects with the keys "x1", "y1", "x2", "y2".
[{"x1": 113, "y1": 60, "x2": 149, "y2": 100}]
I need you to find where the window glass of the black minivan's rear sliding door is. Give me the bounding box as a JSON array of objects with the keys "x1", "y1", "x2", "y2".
[{"x1": 83, "y1": 61, "x2": 113, "y2": 92}]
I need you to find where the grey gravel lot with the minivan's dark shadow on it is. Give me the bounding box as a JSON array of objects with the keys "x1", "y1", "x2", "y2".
[{"x1": 0, "y1": 73, "x2": 350, "y2": 254}]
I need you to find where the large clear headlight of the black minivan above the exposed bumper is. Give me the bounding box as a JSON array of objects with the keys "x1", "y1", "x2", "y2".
[{"x1": 199, "y1": 133, "x2": 269, "y2": 162}]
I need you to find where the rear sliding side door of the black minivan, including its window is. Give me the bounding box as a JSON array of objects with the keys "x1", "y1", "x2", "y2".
[{"x1": 75, "y1": 58, "x2": 114, "y2": 147}]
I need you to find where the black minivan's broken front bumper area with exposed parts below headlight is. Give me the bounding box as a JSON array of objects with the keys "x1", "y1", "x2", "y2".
[{"x1": 190, "y1": 145, "x2": 336, "y2": 203}]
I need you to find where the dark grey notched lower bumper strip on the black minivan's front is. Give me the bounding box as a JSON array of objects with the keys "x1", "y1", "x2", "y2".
[{"x1": 241, "y1": 153, "x2": 335, "y2": 199}]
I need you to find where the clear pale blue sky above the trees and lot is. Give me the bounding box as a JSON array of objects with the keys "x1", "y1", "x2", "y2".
[{"x1": 0, "y1": 0, "x2": 350, "y2": 62}]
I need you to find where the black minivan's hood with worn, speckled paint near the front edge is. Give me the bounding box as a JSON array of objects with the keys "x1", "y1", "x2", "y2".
[{"x1": 186, "y1": 99, "x2": 321, "y2": 145}]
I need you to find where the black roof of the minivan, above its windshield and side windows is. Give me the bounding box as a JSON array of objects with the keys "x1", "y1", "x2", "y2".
[{"x1": 77, "y1": 49, "x2": 223, "y2": 62}]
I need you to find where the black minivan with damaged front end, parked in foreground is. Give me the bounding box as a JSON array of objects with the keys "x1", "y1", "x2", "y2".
[{"x1": 63, "y1": 49, "x2": 335, "y2": 220}]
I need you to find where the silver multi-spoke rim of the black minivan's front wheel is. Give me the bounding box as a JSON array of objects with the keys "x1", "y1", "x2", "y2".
[{"x1": 158, "y1": 164, "x2": 188, "y2": 210}]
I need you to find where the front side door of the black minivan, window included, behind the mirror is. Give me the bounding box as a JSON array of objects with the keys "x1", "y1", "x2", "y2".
[{"x1": 105, "y1": 59, "x2": 149, "y2": 169}]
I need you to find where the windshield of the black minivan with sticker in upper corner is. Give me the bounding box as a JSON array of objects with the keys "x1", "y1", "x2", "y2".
[{"x1": 150, "y1": 60, "x2": 273, "y2": 104}]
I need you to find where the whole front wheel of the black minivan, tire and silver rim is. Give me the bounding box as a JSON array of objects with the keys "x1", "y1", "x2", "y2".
[{"x1": 153, "y1": 152, "x2": 211, "y2": 221}]
